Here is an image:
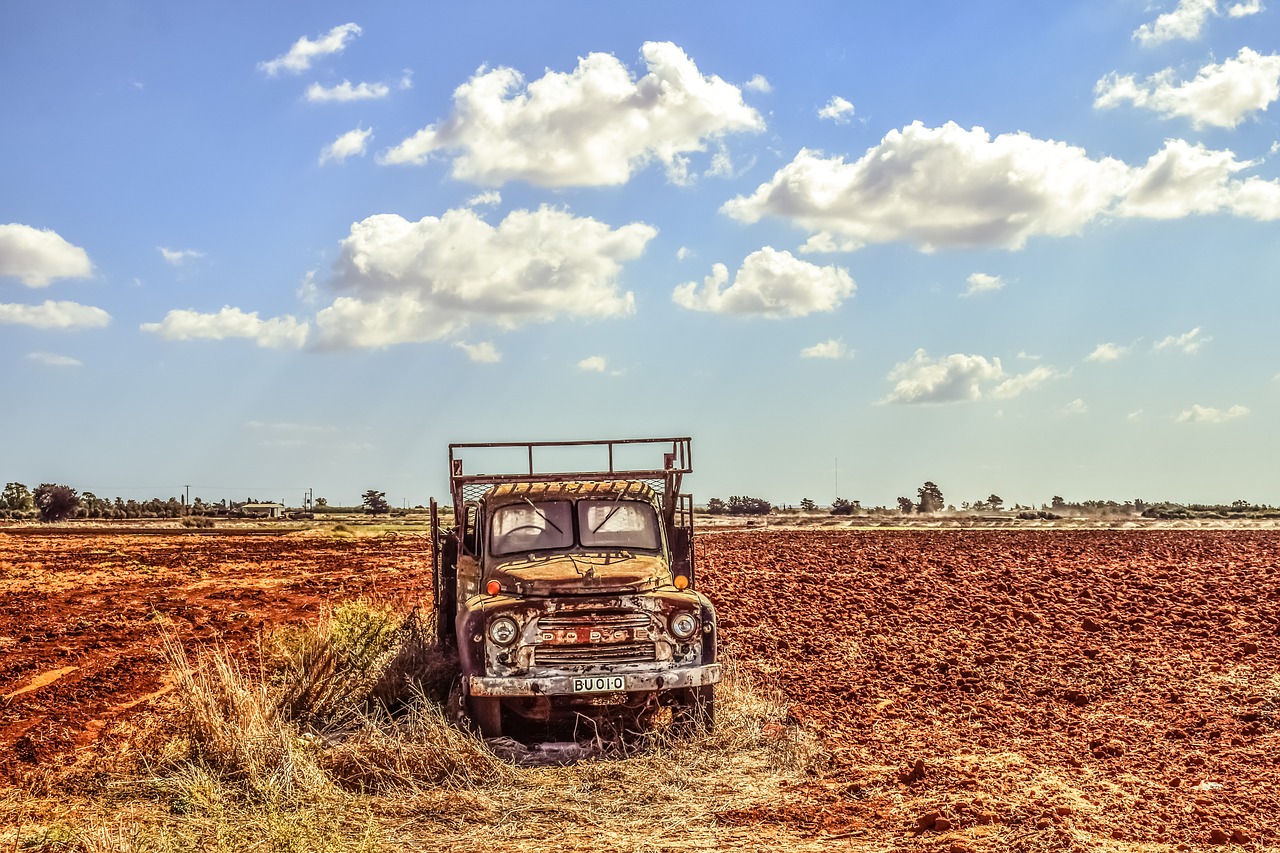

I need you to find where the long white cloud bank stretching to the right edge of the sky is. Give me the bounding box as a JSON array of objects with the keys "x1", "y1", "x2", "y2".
[{"x1": 722, "y1": 122, "x2": 1280, "y2": 251}]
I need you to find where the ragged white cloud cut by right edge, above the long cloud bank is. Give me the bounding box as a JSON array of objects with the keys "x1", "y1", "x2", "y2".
[{"x1": 1093, "y1": 47, "x2": 1280, "y2": 128}]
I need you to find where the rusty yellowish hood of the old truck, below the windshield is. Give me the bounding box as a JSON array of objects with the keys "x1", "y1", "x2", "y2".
[{"x1": 488, "y1": 551, "x2": 671, "y2": 596}]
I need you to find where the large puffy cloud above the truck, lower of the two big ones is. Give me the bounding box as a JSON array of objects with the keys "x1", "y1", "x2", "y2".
[{"x1": 309, "y1": 206, "x2": 657, "y2": 348}]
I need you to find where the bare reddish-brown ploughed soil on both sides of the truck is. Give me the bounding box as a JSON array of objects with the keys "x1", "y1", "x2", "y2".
[{"x1": 0, "y1": 530, "x2": 1280, "y2": 853}]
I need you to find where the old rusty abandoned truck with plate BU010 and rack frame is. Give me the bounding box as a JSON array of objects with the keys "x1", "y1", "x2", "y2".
[{"x1": 431, "y1": 438, "x2": 721, "y2": 738}]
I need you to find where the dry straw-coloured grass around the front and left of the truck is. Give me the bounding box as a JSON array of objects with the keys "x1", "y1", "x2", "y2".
[{"x1": 0, "y1": 603, "x2": 824, "y2": 853}]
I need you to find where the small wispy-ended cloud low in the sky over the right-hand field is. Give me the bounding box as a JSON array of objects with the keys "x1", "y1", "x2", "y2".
[{"x1": 882, "y1": 350, "x2": 1059, "y2": 403}]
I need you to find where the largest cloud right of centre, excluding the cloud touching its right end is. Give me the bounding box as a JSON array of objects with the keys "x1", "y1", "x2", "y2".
[{"x1": 722, "y1": 122, "x2": 1128, "y2": 251}]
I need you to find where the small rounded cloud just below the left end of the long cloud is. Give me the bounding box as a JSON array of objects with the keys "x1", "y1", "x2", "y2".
[{"x1": 672, "y1": 246, "x2": 856, "y2": 319}]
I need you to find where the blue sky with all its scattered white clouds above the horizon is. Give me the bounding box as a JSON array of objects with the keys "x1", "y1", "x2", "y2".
[{"x1": 0, "y1": 0, "x2": 1280, "y2": 506}]
